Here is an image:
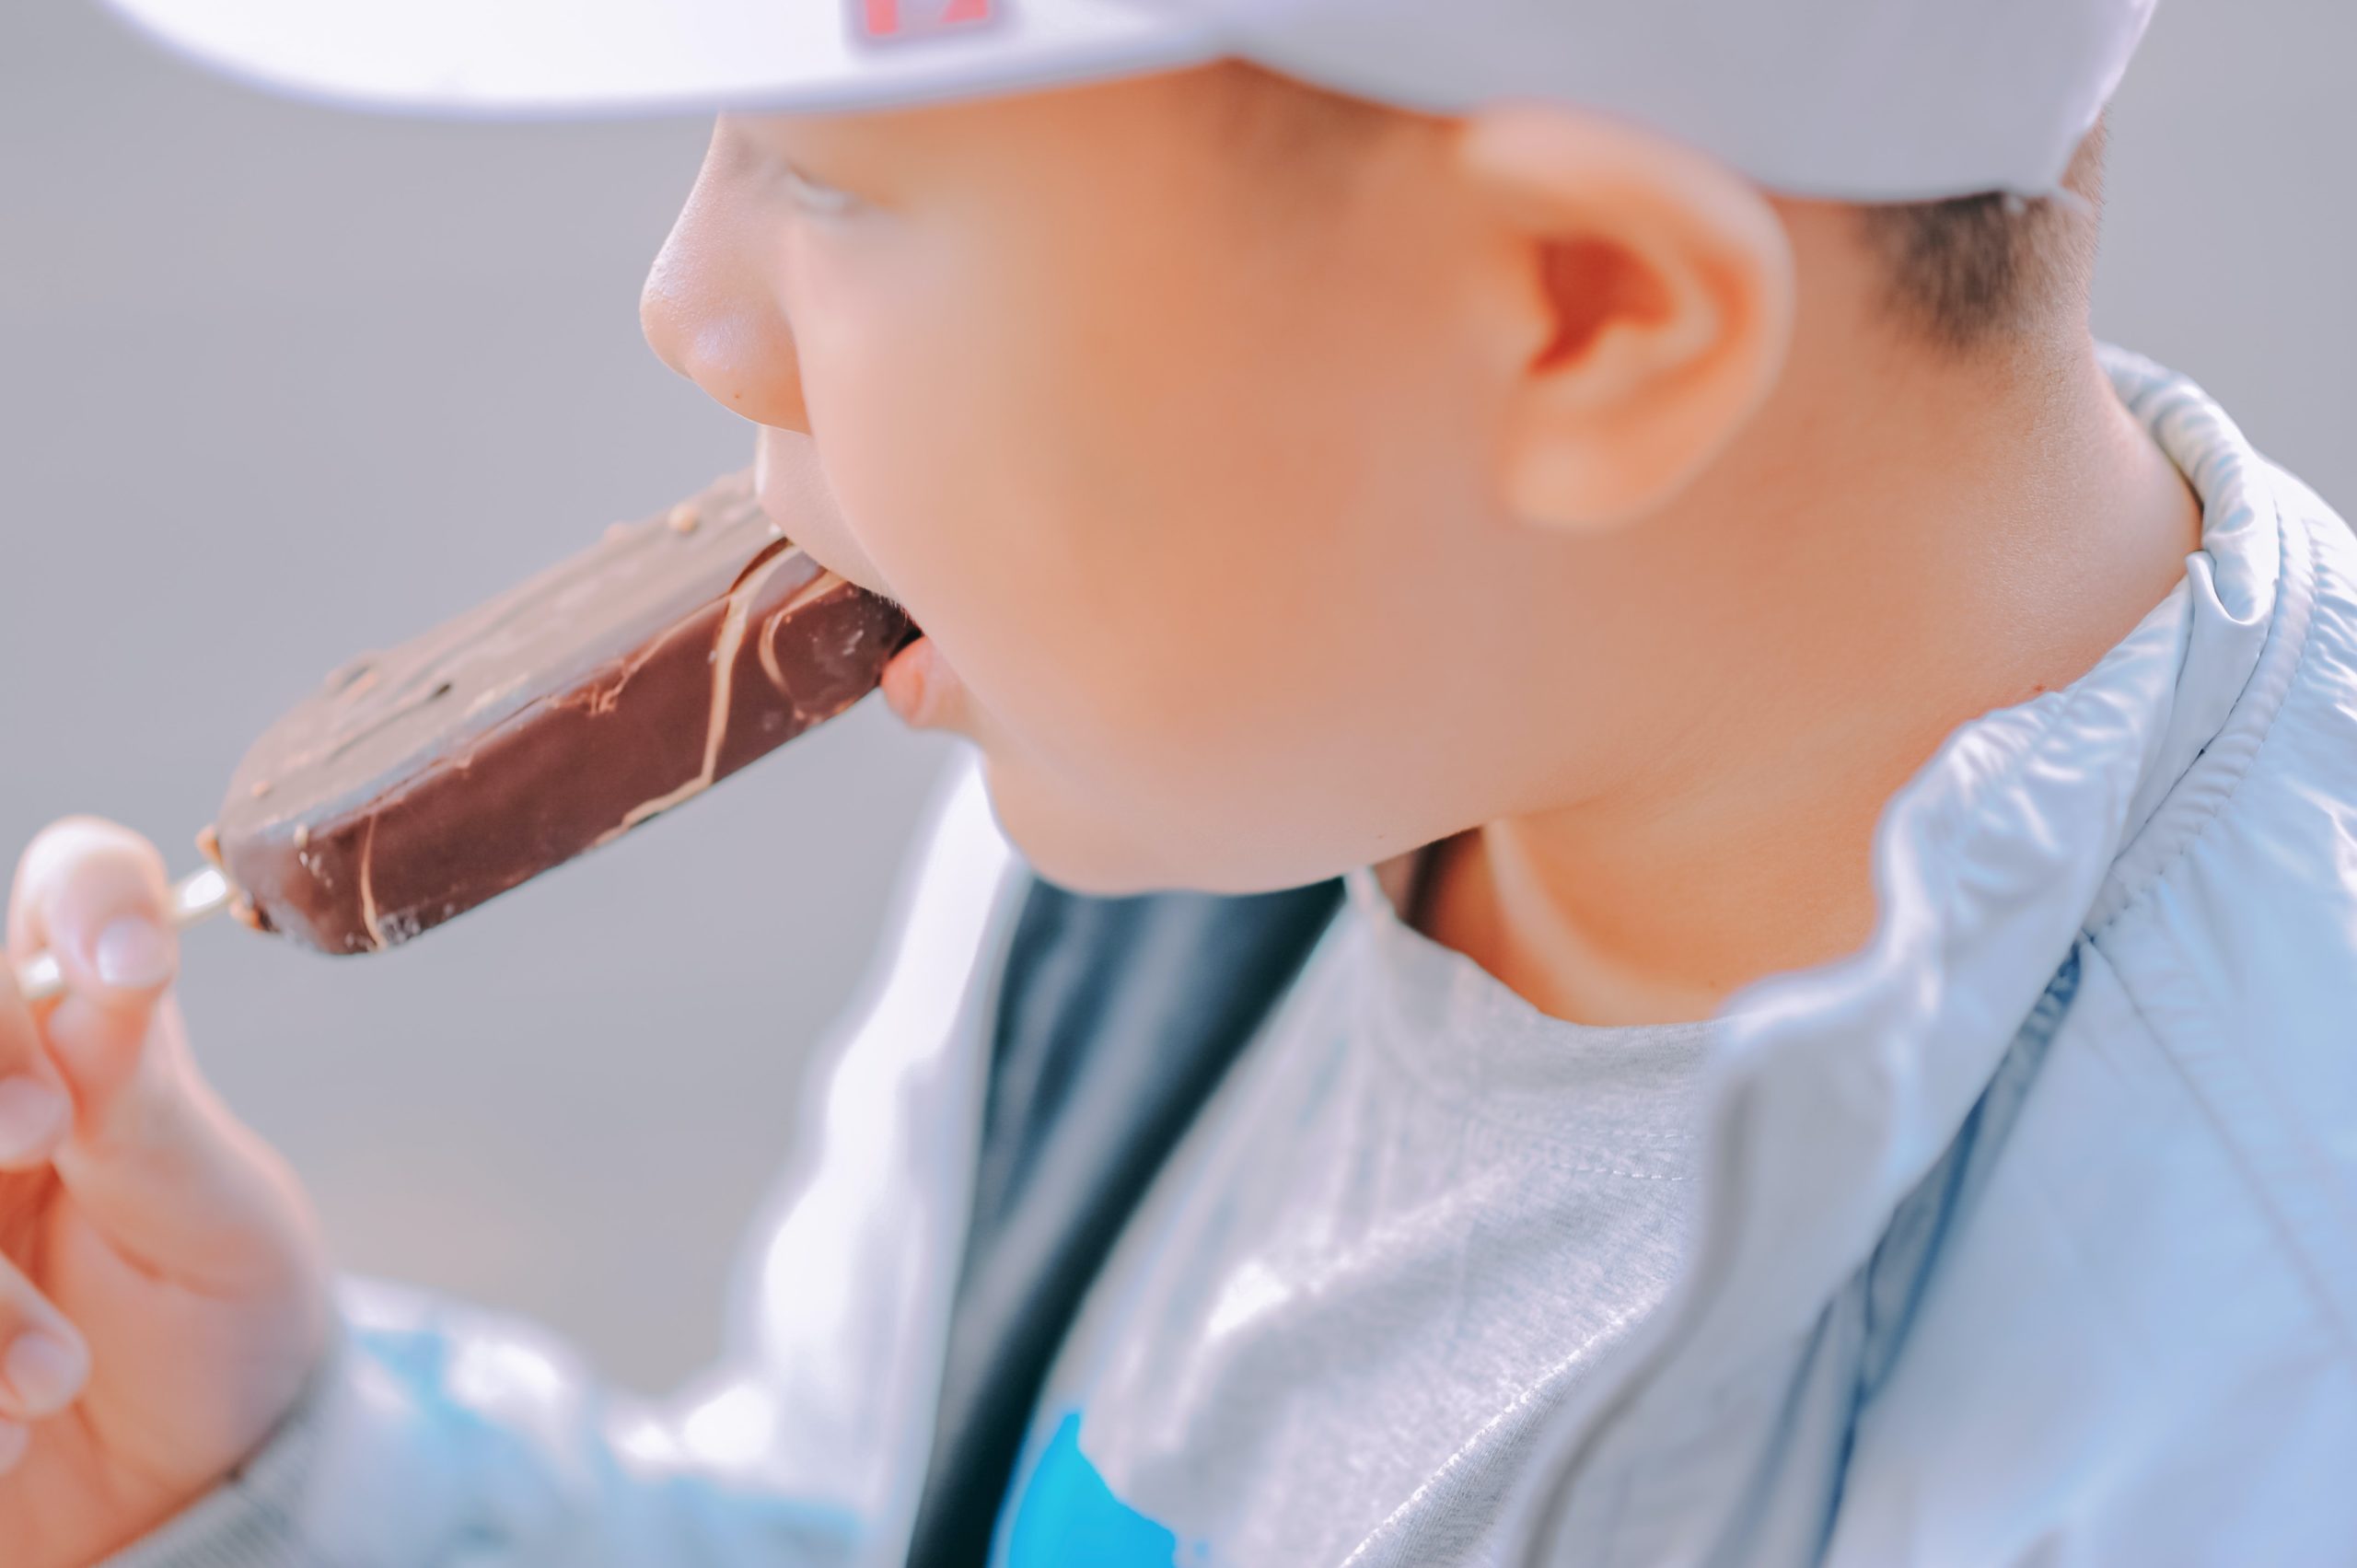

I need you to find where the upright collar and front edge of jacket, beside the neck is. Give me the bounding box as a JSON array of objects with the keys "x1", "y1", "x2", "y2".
[{"x1": 1520, "y1": 349, "x2": 2310, "y2": 1538}]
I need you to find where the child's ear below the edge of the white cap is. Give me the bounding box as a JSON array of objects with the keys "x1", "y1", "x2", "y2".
[{"x1": 1457, "y1": 106, "x2": 1794, "y2": 528}]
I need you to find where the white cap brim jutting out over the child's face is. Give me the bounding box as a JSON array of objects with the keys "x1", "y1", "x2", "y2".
[{"x1": 106, "y1": 0, "x2": 1221, "y2": 118}]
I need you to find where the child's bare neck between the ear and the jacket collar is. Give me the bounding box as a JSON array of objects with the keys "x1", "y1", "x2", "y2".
[{"x1": 1423, "y1": 332, "x2": 2201, "y2": 1023}]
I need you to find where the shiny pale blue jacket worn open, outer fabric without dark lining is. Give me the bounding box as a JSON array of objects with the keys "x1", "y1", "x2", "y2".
[{"x1": 118, "y1": 354, "x2": 2357, "y2": 1568}]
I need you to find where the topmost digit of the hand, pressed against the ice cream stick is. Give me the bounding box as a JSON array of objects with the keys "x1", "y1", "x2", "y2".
[{"x1": 9, "y1": 816, "x2": 180, "y2": 1139}]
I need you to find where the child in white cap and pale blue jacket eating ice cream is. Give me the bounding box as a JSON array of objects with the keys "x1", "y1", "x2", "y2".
[{"x1": 0, "y1": 0, "x2": 2357, "y2": 1568}]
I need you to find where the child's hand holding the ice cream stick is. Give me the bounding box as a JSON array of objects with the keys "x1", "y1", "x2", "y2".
[{"x1": 0, "y1": 819, "x2": 328, "y2": 1568}]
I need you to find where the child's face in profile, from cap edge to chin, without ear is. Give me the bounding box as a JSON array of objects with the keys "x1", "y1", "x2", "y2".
[{"x1": 645, "y1": 71, "x2": 1643, "y2": 891}]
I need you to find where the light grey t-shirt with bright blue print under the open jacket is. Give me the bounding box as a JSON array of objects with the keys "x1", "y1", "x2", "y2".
[{"x1": 993, "y1": 867, "x2": 1712, "y2": 1568}]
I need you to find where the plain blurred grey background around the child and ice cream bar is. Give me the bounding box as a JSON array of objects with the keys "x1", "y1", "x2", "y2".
[{"x1": 0, "y1": 0, "x2": 2357, "y2": 1388}]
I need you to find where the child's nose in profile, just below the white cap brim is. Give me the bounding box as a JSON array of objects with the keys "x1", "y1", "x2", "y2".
[{"x1": 639, "y1": 130, "x2": 811, "y2": 434}]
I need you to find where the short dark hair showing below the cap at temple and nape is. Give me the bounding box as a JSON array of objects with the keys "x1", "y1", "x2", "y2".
[{"x1": 1213, "y1": 62, "x2": 2105, "y2": 354}]
